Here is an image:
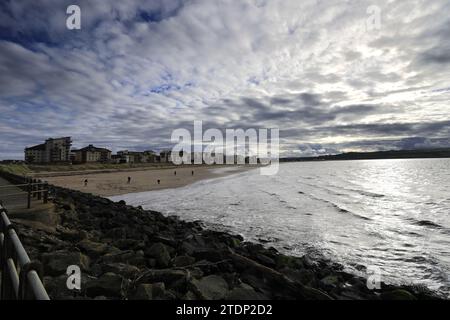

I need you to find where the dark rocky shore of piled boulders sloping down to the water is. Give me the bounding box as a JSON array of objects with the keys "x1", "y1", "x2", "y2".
[{"x1": 16, "y1": 188, "x2": 442, "y2": 300}]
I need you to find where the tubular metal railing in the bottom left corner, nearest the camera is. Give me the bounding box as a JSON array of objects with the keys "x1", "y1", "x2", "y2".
[{"x1": 0, "y1": 201, "x2": 50, "y2": 300}]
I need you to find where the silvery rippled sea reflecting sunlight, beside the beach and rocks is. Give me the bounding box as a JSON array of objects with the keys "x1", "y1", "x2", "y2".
[{"x1": 110, "y1": 159, "x2": 450, "y2": 298}]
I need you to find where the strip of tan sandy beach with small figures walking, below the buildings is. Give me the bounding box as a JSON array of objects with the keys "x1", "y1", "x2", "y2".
[{"x1": 44, "y1": 165, "x2": 255, "y2": 196}]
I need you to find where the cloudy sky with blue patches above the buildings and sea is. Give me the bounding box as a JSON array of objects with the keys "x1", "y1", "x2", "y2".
[{"x1": 0, "y1": 0, "x2": 450, "y2": 159}]
